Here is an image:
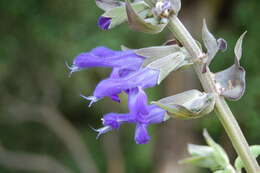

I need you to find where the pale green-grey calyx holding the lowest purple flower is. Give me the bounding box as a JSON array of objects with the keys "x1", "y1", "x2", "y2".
[{"x1": 153, "y1": 90, "x2": 215, "y2": 119}]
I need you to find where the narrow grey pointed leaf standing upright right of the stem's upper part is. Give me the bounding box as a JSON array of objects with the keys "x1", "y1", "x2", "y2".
[{"x1": 202, "y1": 19, "x2": 219, "y2": 66}]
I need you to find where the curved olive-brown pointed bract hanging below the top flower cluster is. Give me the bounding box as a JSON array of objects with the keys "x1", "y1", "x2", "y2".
[{"x1": 126, "y1": 1, "x2": 167, "y2": 34}]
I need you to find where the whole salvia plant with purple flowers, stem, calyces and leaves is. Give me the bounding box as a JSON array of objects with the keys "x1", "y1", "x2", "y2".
[{"x1": 69, "y1": 0, "x2": 260, "y2": 173}]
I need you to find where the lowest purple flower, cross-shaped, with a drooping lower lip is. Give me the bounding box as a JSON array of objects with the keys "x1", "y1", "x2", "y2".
[{"x1": 96, "y1": 87, "x2": 166, "y2": 144}]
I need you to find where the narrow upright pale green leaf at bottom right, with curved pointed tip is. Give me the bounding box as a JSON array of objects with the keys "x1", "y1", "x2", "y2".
[{"x1": 203, "y1": 129, "x2": 230, "y2": 169}]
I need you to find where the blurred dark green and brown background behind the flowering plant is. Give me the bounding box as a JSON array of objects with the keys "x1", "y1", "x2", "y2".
[{"x1": 0, "y1": 0, "x2": 260, "y2": 173}]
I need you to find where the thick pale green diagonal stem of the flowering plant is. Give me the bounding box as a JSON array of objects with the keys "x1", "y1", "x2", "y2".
[{"x1": 168, "y1": 16, "x2": 260, "y2": 173}]
